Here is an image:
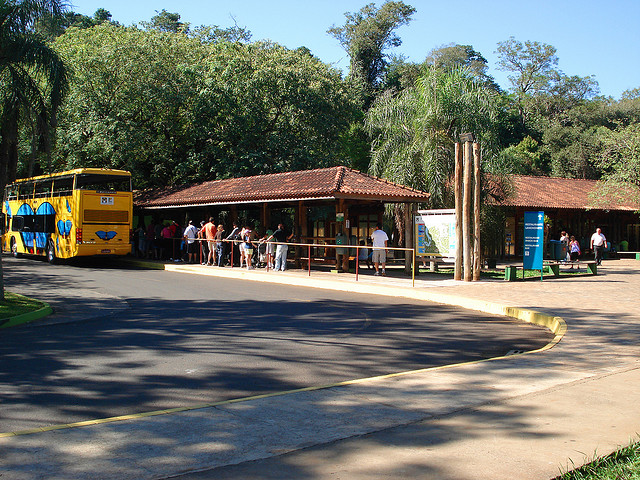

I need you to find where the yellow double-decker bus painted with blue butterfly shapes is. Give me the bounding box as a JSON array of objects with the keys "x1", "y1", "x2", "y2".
[{"x1": 2, "y1": 168, "x2": 133, "y2": 263}]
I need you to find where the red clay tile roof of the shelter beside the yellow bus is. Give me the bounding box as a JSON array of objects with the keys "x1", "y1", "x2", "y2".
[{"x1": 134, "y1": 167, "x2": 429, "y2": 208}]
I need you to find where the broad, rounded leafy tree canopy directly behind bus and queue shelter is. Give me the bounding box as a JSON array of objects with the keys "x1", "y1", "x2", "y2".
[{"x1": 49, "y1": 24, "x2": 358, "y2": 187}]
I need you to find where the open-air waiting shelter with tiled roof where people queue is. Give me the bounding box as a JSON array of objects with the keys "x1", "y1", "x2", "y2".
[{"x1": 134, "y1": 166, "x2": 429, "y2": 269}]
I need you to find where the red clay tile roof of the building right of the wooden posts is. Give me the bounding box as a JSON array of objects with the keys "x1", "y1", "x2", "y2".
[{"x1": 490, "y1": 175, "x2": 640, "y2": 211}]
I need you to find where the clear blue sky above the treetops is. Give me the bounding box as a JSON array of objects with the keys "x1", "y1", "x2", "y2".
[{"x1": 70, "y1": 0, "x2": 640, "y2": 99}]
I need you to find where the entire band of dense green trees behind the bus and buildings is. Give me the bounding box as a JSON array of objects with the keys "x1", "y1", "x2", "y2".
[{"x1": 0, "y1": 0, "x2": 640, "y2": 206}]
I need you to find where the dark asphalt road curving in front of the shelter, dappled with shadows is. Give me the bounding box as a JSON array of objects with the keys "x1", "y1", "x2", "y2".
[{"x1": 0, "y1": 256, "x2": 552, "y2": 432}]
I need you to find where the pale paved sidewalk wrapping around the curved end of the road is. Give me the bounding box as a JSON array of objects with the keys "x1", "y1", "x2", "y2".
[{"x1": 0, "y1": 260, "x2": 640, "y2": 480}]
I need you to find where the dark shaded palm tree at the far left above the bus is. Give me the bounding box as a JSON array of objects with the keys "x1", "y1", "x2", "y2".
[{"x1": 0, "y1": 0, "x2": 68, "y2": 300}]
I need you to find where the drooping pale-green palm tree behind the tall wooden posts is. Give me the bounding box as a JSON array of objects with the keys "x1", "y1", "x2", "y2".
[{"x1": 366, "y1": 67, "x2": 499, "y2": 207}]
